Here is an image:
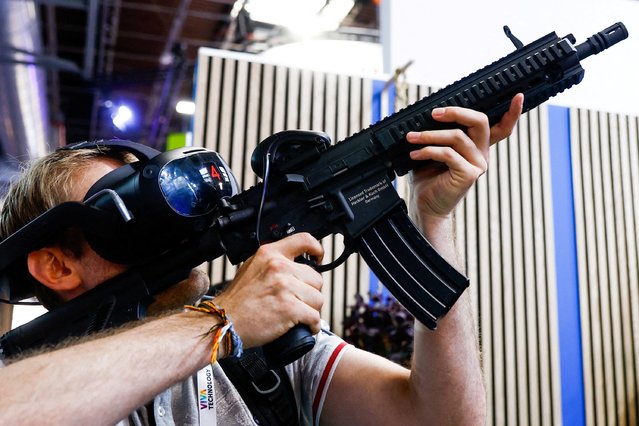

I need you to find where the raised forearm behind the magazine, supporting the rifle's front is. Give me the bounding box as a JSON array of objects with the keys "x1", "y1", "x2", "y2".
[{"x1": 411, "y1": 211, "x2": 486, "y2": 424}]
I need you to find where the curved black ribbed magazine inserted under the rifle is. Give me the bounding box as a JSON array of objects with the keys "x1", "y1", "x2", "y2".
[{"x1": 357, "y1": 205, "x2": 469, "y2": 330}]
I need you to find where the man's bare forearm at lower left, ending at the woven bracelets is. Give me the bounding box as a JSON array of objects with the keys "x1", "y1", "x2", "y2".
[{"x1": 0, "y1": 312, "x2": 214, "y2": 425}]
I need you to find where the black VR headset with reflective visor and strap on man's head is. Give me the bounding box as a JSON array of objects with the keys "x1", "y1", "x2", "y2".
[{"x1": 0, "y1": 139, "x2": 238, "y2": 303}]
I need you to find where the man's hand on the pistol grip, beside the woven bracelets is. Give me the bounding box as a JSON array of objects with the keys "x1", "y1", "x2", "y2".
[{"x1": 215, "y1": 233, "x2": 324, "y2": 348}]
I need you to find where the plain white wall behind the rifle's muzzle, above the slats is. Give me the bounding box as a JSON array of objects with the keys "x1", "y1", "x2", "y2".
[{"x1": 381, "y1": 0, "x2": 639, "y2": 115}]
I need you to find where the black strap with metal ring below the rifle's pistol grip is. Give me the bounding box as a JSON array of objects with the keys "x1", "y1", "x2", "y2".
[{"x1": 219, "y1": 348, "x2": 299, "y2": 426}]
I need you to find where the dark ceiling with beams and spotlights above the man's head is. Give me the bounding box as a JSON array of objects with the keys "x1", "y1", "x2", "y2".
[{"x1": 36, "y1": 0, "x2": 378, "y2": 148}]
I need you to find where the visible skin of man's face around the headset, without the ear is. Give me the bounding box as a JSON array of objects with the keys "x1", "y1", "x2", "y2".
[{"x1": 72, "y1": 158, "x2": 210, "y2": 313}]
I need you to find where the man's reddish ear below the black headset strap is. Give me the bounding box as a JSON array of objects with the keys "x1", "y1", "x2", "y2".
[{"x1": 27, "y1": 246, "x2": 82, "y2": 292}]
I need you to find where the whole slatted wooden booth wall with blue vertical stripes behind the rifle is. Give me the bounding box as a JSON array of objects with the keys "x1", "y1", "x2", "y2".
[{"x1": 193, "y1": 49, "x2": 639, "y2": 425}]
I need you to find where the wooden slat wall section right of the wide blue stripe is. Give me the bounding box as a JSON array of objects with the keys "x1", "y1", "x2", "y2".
[{"x1": 571, "y1": 109, "x2": 639, "y2": 425}]
